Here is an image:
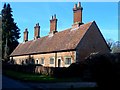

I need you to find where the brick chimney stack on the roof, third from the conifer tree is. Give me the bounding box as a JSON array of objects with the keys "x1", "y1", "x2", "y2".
[{"x1": 50, "y1": 14, "x2": 57, "y2": 34}]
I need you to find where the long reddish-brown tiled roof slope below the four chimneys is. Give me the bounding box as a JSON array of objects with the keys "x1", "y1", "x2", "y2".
[{"x1": 10, "y1": 22, "x2": 93, "y2": 56}]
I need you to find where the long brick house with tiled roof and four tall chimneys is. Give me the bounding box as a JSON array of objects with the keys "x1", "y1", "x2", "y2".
[{"x1": 10, "y1": 3, "x2": 110, "y2": 67}]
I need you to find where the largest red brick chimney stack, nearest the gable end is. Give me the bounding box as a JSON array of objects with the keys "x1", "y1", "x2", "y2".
[{"x1": 72, "y1": 2, "x2": 83, "y2": 27}]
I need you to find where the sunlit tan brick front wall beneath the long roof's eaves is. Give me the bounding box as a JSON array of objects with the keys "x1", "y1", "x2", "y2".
[{"x1": 13, "y1": 51, "x2": 76, "y2": 67}]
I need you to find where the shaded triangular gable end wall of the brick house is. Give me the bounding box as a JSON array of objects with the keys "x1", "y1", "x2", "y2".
[{"x1": 76, "y1": 22, "x2": 110, "y2": 61}]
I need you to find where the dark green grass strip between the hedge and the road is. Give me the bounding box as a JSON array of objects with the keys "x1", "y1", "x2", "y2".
[{"x1": 3, "y1": 70, "x2": 81, "y2": 83}]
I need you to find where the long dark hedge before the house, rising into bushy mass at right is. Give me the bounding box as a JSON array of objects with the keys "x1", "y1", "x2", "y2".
[{"x1": 3, "y1": 53, "x2": 120, "y2": 89}]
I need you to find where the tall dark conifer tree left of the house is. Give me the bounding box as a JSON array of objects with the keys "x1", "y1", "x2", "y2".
[{"x1": 1, "y1": 3, "x2": 20, "y2": 60}]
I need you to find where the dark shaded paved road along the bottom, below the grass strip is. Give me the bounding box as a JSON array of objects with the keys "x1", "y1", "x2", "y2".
[{"x1": 2, "y1": 76, "x2": 96, "y2": 90}]
